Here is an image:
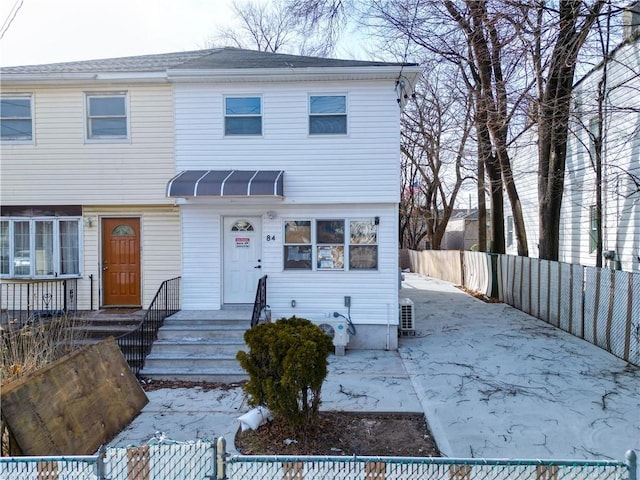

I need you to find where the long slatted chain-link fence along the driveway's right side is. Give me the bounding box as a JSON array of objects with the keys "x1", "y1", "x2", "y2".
[{"x1": 409, "y1": 250, "x2": 640, "y2": 366}]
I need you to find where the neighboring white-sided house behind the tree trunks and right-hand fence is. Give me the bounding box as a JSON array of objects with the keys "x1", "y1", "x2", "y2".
[{"x1": 505, "y1": 5, "x2": 640, "y2": 271}]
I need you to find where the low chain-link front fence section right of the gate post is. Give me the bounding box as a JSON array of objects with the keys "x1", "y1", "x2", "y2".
[{"x1": 225, "y1": 456, "x2": 629, "y2": 480}]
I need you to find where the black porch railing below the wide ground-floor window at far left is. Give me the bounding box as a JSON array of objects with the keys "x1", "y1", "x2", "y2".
[{"x1": 0, "y1": 278, "x2": 78, "y2": 326}]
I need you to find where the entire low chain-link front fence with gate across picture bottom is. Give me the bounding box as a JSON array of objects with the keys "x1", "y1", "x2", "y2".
[{"x1": 0, "y1": 438, "x2": 638, "y2": 480}]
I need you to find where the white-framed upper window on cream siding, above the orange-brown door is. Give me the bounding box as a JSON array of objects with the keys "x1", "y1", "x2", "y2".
[{"x1": 87, "y1": 93, "x2": 129, "y2": 140}]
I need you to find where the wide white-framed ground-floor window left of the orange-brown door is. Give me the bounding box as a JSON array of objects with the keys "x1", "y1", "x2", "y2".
[{"x1": 0, "y1": 217, "x2": 81, "y2": 278}]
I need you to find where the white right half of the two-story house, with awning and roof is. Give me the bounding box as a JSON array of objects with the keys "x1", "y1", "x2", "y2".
[{"x1": 167, "y1": 49, "x2": 418, "y2": 349}]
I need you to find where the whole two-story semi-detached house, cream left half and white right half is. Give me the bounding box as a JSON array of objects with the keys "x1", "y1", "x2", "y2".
[{"x1": 0, "y1": 48, "x2": 419, "y2": 348}]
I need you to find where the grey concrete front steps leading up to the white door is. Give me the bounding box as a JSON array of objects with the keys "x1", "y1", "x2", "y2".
[{"x1": 140, "y1": 306, "x2": 252, "y2": 383}]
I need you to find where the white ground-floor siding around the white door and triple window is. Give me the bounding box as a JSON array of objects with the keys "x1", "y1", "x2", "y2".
[{"x1": 181, "y1": 204, "x2": 398, "y2": 335}]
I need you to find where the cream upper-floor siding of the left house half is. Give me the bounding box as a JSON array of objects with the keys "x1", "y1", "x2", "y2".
[{"x1": 0, "y1": 85, "x2": 175, "y2": 205}]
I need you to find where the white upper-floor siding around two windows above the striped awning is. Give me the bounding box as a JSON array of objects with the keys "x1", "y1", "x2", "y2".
[{"x1": 175, "y1": 82, "x2": 400, "y2": 204}]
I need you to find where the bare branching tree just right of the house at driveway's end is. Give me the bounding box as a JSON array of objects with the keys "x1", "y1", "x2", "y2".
[{"x1": 400, "y1": 66, "x2": 473, "y2": 250}]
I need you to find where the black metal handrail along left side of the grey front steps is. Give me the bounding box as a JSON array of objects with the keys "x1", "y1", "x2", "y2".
[{"x1": 116, "y1": 277, "x2": 181, "y2": 376}]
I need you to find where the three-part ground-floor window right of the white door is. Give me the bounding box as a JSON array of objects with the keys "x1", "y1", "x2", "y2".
[{"x1": 284, "y1": 219, "x2": 378, "y2": 271}]
